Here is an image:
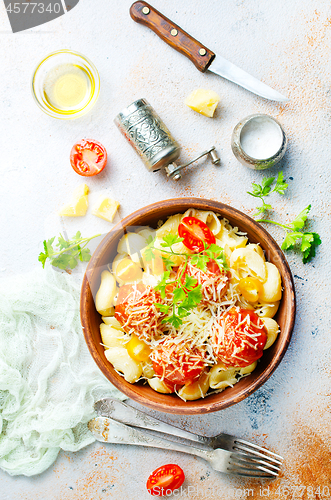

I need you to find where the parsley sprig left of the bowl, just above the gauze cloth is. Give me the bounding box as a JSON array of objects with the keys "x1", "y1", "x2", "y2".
[{"x1": 38, "y1": 231, "x2": 101, "y2": 270}]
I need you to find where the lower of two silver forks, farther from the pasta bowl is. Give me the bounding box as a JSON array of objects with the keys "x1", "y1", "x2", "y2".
[{"x1": 88, "y1": 417, "x2": 277, "y2": 479}]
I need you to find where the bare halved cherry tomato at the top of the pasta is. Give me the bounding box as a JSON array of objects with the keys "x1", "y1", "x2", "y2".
[{"x1": 178, "y1": 217, "x2": 216, "y2": 252}]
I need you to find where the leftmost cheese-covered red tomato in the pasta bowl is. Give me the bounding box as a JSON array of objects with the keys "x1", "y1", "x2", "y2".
[{"x1": 115, "y1": 283, "x2": 163, "y2": 342}]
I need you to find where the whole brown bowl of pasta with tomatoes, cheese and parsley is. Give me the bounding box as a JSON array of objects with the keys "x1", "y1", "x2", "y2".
[{"x1": 81, "y1": 199, "x2": 295, "y2": 414}]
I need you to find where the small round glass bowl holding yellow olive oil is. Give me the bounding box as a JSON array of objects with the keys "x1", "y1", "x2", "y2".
[{"x1": 32, "y1": 50, "x2": 100, "y2": 120}]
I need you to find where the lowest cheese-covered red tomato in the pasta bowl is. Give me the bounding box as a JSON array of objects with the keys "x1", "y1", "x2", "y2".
[{"x1": 150, "y1": 335, "x2": 205, "y2": 385}]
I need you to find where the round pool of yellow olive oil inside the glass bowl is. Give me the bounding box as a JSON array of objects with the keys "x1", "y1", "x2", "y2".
[{"x1": 44, "y1": 64, "x2": 91, "y2": 112}]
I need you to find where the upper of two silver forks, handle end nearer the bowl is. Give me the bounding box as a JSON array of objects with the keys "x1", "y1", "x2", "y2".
[{"x1": 94, "y1": 398, "x2": 283, "y2": 475}]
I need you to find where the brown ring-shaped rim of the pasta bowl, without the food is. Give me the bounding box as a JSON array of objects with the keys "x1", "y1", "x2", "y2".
[{"x1": 80, "y1": 198, "x2": 296, "y2": 415}]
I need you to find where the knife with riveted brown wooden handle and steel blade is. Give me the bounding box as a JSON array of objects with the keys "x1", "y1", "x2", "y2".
[{"x1": 130, "y1": 1, "x2": 289, "y2": 102}]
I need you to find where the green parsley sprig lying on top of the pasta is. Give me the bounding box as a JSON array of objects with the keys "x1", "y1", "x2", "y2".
[{"x1": 144, "y1": 234, "x2": 227, "y2": 328}]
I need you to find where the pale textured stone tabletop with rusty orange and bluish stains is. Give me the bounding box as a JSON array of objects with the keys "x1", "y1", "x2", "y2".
[{"x1": 0, "y1": 0, "x2": 331, "y2": 500}]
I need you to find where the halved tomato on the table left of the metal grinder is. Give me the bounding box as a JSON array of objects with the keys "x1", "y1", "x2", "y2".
[{"x1": 70, "y1": 139, "x2": 107, "y2": 176}]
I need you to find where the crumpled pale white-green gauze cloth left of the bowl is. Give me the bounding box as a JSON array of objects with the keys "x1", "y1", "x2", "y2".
[{"x1": 0, "y1": 266, "x2": 124, "y2": 476}]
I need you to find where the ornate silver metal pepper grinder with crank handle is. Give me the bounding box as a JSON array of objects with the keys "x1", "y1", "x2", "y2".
[{"x1": 114, "y1": 99, "x2": 220, "y2": 181}]
